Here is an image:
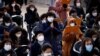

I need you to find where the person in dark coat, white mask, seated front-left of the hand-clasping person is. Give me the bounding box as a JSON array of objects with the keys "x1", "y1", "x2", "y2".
[{"x1": 31, "y1": 31, "x2": 47, "y2": 56}]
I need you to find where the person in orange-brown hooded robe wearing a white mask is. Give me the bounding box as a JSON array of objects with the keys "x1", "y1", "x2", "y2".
[{"x1": 62, "y1": 17, "x2": 82, "y2": 56}]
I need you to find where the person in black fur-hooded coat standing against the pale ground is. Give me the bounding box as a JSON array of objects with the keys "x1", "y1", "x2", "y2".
[{"x1": 24, "y1": 5, "x2": 40, "y2": 39}]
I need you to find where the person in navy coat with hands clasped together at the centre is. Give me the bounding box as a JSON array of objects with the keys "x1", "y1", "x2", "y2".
[{"x1": 44, "y1": 12, "x2": 61, "y2": 56}]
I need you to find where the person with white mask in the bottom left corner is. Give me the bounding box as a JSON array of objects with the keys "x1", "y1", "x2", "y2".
[{"x1": 0, "y1": 39, "x2": 17, "y2": 56}]
